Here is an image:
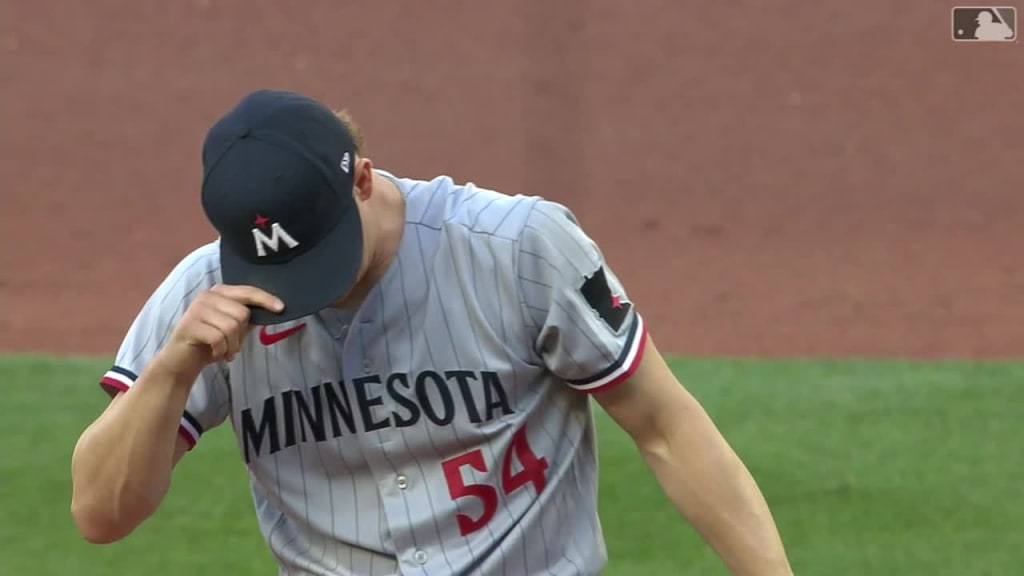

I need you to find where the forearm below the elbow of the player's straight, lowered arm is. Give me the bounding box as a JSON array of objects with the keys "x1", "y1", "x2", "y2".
[{"x1": 640, "y1": 411, "x2": 793, "y2": 576}]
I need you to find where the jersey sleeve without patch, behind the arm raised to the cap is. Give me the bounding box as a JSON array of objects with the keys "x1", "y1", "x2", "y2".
[{"x1": 99, "y1": 240, "x2": 230, "y2": 450}]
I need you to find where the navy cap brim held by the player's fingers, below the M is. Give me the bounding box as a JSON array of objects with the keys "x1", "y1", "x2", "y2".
[{"x1": 220, "y1": 207, "x2": 362, "y2": 326}]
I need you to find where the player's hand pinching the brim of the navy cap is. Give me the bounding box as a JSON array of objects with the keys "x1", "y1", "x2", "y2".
[{"x1": 153, "y1": 284, "x2": 285, "y2": 376}]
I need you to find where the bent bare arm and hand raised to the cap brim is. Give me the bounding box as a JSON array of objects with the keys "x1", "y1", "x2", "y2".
[{"x1": 71, "y1": 286, "x2": 283, "y2": 543}]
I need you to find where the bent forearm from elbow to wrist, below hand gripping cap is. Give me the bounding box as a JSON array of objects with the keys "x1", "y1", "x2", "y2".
[{"x1": 72, "y1": 356, "x2": 195, "y2": 543}]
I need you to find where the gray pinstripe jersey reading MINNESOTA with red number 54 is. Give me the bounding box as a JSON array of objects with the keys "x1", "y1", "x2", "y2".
[{"x1": 102, "y1": 168, "x2": 645, "y2": 576}]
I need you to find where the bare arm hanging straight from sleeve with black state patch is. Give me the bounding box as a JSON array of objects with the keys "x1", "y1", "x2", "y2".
[{"x1": 594, "y1": 339, "x2": 793, "y2": 576}]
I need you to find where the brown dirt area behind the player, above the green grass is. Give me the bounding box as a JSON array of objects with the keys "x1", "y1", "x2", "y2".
[{"x1": 0, "y1": 0, "x2": 1024, "y2": 358}]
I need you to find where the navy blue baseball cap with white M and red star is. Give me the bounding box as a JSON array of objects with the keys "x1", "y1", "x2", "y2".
[{"x1": 202, "y1": 90, "x2": 362, "y2": 325}]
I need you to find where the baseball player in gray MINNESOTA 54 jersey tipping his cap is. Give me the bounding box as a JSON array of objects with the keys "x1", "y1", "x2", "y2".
[{"x1": 72, "y1": 90, "x2": 791, "y2": 576}]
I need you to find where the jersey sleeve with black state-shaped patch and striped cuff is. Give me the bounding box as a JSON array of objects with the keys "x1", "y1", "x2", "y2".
[{"x1": 516, "y1": 200, "x2": 646, "y2": 393}]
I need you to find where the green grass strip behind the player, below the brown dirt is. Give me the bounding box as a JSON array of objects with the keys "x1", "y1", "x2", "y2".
[{"x1": 0, "y1": 358, "x2": 1024, "y2": 576}]
